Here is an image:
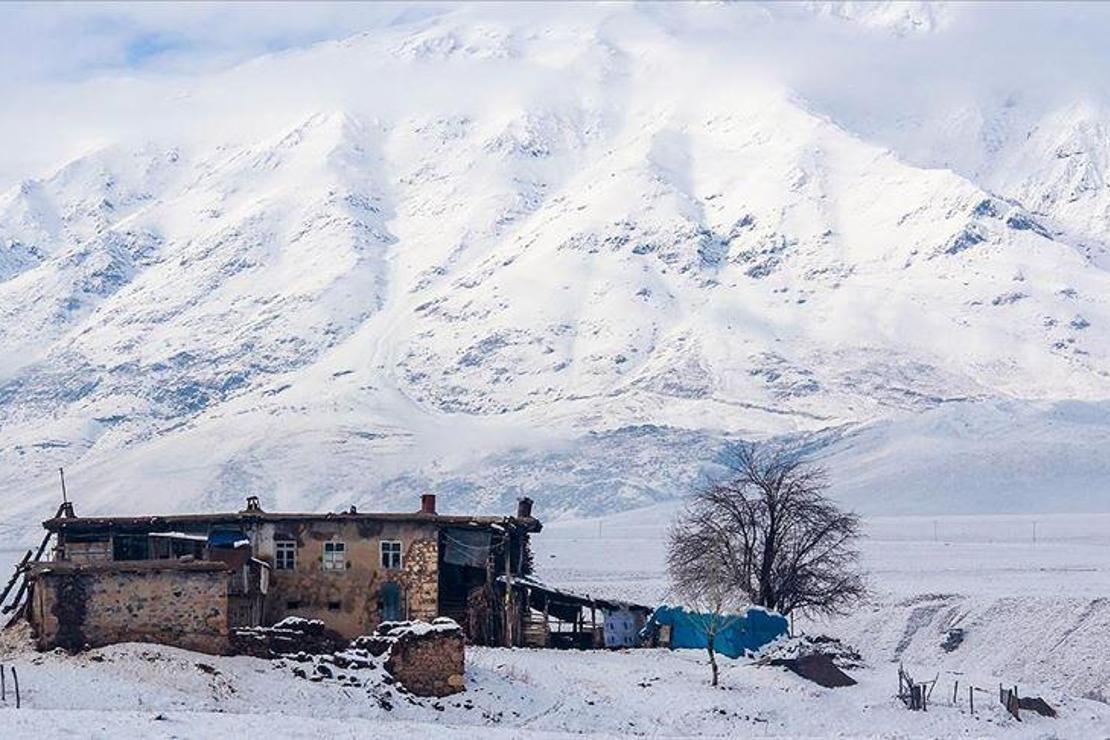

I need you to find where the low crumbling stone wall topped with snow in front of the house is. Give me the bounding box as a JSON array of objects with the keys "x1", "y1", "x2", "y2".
[{"x1": 353, "y1": 617, "x2": 466, "y2": 697}]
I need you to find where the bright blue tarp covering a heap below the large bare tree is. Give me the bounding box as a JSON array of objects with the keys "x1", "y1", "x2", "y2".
[{"x1": 640, "y1": 607, "x2": 788, "y2": 658}]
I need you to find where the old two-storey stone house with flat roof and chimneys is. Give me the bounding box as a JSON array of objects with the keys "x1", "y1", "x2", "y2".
[{"x1": 28, "y1": 495, "x2": 541, "y2": 652}]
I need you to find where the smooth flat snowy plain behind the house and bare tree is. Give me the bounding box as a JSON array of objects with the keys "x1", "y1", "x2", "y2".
[{"x1": 535, "y1": 504, "x2": 1110, "y2": 604}]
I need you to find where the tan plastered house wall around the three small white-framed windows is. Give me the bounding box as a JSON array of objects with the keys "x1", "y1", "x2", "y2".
[{"x1": 256, "y1": 520, "x2": 440, "y2": 638}]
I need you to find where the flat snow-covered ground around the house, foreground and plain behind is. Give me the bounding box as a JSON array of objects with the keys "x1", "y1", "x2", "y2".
[{"x1": 0, "y1": 507, "x2": 1110, "y2": 738}]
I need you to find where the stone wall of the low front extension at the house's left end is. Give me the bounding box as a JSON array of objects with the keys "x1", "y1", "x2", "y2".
[{"x1": 30, "y1": 560, "x2": 229, "y2": 653}]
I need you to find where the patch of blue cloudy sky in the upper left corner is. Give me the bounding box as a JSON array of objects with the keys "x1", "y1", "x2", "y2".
[{"x1": 0, "y1": 2, "x2": 441, "y2": 189}]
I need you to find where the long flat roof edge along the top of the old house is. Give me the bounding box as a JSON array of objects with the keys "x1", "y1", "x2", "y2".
[{"x1": 42, "y1": 511, "x2": 543, "y2": 531}]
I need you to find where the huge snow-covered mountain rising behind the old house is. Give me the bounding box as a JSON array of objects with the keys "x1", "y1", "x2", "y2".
[{"x1": 0, "y1": 3, "x2": 1110, "y2": 519}]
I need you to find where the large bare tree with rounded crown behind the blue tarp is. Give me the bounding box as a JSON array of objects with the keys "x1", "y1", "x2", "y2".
[{"x1": 667, "y1": 445, "x2": 866, "y2": 685}]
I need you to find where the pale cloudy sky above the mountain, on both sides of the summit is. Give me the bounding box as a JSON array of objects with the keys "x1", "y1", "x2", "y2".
[{"x1": 0, "y1": 2, "x2": 1110, "y2": 190}]
